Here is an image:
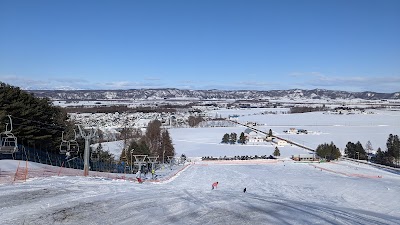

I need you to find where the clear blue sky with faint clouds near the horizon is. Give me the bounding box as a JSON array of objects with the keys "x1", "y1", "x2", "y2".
[{"x1": 0, "y1": 0, "x2": 400, "y2": 92}]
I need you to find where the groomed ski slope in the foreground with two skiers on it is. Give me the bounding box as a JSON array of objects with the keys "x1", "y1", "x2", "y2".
[{"x1": 0, "y1": 161, "x2": 400, "y2": 225}]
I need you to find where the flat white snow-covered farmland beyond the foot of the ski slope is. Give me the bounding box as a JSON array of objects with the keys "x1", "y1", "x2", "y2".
[{"x1": 170, "y1": 109, "x2": 400, "y2": 157}]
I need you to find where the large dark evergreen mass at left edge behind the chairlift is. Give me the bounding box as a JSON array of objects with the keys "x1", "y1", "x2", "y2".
[{"x1": 0, "y1": 82, "x2": 73, "y2": 151}]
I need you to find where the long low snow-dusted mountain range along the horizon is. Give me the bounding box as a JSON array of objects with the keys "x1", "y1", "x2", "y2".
[{"x1": 28, "y1": 88, "x2": 400, "y2": 100}]
